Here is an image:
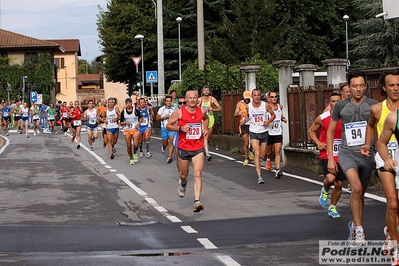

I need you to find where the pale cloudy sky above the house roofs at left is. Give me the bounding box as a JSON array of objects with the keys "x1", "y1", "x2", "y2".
[{"x1": 0, "y1": 0, "x2": 107, "y2": 62}]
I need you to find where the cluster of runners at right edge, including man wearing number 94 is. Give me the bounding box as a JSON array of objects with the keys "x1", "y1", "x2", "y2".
[{"x1": 309, "y1": 69, "x2": 399, "y2": 265}]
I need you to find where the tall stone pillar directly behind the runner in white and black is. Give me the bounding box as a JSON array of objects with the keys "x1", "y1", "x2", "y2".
[{"x1": 273, "y1": 60, "x2": 296, "y2": 165}]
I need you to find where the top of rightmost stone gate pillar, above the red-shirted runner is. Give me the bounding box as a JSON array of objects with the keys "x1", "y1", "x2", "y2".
[{"x1": 321, "y1": 58, "x2": 346, "y2": 89}]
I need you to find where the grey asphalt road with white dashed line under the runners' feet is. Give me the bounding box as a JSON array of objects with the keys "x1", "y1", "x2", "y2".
[{"x1": 0, "y1": 128, "x2": 385, "y2": 266}]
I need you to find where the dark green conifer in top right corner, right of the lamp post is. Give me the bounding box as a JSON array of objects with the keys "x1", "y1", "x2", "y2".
[{"x1": 349, "y1": 0, "x2": 399, "y2": 68}]
